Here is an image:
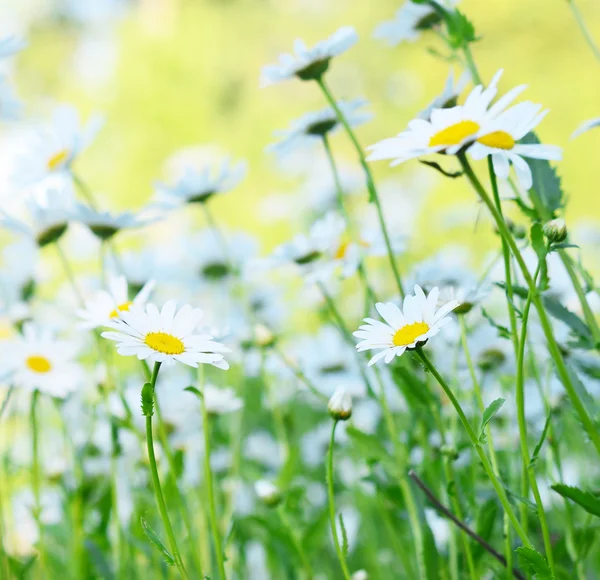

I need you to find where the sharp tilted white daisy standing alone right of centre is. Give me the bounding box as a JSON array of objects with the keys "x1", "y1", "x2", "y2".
[{"x1": 354, "y1": 285, "x2": 459, "y2": 366}]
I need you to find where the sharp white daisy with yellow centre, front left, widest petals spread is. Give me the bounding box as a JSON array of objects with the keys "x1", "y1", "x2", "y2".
[{"x1": 102, "y1": 300, "x2": 231, "y2": 369}]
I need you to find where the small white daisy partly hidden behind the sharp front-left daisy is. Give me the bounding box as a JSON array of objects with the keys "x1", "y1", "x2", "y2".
[{"x1": 77, "y1": 275, "x2": 154, "y2": 328}]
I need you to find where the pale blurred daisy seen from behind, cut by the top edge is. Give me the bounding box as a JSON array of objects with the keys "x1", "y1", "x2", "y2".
[{"x1": 373, "y1": 0, "x2": 448, "y2": 46}]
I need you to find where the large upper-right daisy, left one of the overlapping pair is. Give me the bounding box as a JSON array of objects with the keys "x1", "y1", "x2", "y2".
[{"x1": 367, "y1": 70, "x2": 526, "y2": 166}]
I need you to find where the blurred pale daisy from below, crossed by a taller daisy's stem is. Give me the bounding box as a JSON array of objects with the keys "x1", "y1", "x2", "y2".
[{"x1": 267, "y1": 99, "x2": 373, "y2": 155}]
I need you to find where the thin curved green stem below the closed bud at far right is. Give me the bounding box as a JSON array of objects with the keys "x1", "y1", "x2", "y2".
[{"x1": 516, "y1": 262, "x2": 555, "y2": 576}]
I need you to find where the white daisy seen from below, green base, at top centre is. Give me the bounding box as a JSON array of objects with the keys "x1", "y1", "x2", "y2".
[{"x1": 260, "y1": 26, "x2": 358, "y2": 87}]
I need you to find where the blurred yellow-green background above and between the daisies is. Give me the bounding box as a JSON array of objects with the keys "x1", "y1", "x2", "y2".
[{"x1": 0, "y1": 0, "x2": 600, "y2": 254}]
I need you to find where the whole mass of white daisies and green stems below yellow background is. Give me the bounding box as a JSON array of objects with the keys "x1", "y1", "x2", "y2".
[{"x1": 0, "y1": 0, "x2": 600, "y2": 580}]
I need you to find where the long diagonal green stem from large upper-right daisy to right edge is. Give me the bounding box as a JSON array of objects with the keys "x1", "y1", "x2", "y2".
[{"x1": 458, "y1": 153, "x2": 600, "y2": 454}]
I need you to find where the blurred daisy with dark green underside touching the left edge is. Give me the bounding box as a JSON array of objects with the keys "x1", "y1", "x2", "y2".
[{"x1": 0, "y1": 190, "x2": 72, "y2": 248}]
